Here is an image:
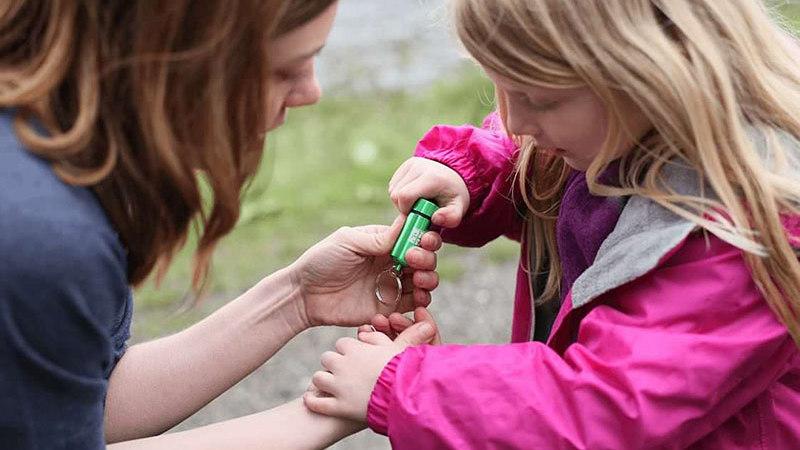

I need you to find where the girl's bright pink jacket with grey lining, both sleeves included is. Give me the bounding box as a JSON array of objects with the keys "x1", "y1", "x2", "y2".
[{"x1": 367, "y1": 120, "x2": 800, "y2": 450}]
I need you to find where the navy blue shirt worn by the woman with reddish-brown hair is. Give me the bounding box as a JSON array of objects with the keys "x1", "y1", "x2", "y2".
[{"x1": 0, "y1": 110, "x2": 131, "y2": 450}]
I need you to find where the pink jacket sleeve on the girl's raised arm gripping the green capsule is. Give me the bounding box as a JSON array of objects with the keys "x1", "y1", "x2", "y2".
[{"x1": 414, "y1": 113, "x2": 522, "y2": 247}]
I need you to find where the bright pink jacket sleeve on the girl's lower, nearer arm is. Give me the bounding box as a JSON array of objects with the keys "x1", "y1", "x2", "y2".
[{"x1": 368, "y1": 230, "x2": 797, "y2": 449}]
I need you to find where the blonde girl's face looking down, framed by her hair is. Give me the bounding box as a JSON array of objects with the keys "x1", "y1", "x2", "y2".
[{"x1": 485, "y1": 69, "x2": 651, "y2": 171}]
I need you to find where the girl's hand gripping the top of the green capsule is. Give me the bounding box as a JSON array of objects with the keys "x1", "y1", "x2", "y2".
[{"x1": 389, "y1": 157, "x2": 469, "y2": 228}]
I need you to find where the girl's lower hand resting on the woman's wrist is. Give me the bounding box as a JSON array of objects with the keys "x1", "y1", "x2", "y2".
[{"x1": 303, "y1": 308, "x2": 438, "y2": 422}]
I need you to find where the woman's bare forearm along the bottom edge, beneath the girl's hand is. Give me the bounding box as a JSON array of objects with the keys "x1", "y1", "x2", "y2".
[{"x1": 108, "y1": 399, "x2": 364, "y2": 450}]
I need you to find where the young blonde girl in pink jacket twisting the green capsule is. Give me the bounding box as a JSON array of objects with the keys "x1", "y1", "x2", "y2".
[{"x1": 305, "y1": 0, "x2": 800, "y2": 449}]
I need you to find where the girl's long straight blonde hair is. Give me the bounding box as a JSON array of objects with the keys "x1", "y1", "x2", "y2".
[{"x1": 454, "y1": 0, "x2": 800, "y2": 343}]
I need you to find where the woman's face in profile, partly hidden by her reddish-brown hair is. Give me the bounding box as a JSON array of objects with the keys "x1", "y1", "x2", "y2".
[{"x1": 267, "y1": 2, "x2": 338, "y2": 131}]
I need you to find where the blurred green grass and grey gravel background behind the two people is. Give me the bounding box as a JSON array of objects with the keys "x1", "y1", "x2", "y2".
[{"x1": 132, "y1": 0, "x2": 800, "y2": 449}]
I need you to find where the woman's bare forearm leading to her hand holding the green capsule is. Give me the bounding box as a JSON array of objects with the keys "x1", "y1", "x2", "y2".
[{"x1": 105, "y1": 269, "x2": 307, "y2": 442}]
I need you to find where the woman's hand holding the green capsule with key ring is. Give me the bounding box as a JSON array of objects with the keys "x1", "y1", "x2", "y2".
[{"x1": 291, "y1": 216, "x2": 442, "y2": 327}]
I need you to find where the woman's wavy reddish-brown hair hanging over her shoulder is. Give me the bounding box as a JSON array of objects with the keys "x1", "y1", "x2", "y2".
[{"x1": 0, "y1": 0, "x2": 335, "y2": 289}]
